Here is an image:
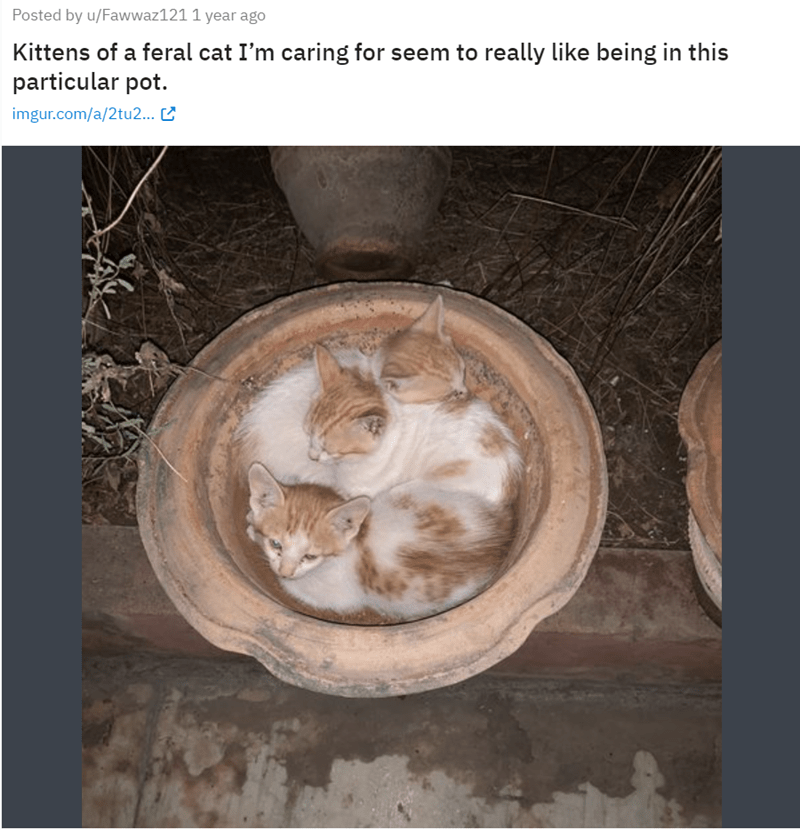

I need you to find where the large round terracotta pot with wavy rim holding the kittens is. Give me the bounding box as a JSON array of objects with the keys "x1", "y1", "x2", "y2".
[{"x1": 137, "y1": 283, "x2": 607, "y2": 697}]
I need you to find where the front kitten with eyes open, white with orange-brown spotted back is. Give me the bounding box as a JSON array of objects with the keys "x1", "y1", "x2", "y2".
[{"x1": 247, "y1": 463, "x2": 513, "y2": 619}]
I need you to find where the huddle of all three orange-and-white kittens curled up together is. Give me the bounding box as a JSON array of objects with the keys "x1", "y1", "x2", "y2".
[{"x1": 237, "y1": 296, "x2": 523, "y2": 618}]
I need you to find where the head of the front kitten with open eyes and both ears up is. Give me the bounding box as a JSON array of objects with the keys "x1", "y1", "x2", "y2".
[{"x1": 247, "y1": 462, "x2": 370, "y2": 579}]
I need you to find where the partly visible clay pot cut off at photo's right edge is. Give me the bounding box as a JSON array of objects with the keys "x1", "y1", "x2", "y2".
[{"x1": 678, "y1": 340, "x2": 722, "y2": 610}]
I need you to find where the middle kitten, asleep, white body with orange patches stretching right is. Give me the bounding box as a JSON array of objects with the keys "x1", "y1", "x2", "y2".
[{"x1": 305, "y1": 347, "x2": 522, "y2": 505}]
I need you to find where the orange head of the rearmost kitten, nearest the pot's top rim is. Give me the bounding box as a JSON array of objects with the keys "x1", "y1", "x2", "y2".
[{"x1": 381, "y1": 296, "x2": 467, "y2": 403}]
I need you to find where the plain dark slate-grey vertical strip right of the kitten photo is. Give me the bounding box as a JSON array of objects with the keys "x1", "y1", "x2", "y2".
[{"x1": 722, "y1": 147, "x2": 800, "y2": 827}]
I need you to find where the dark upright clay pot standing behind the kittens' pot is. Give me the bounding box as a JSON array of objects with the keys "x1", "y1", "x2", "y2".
[{"x1": 270, "y1": 147, "x2": 451, "y2": 281}]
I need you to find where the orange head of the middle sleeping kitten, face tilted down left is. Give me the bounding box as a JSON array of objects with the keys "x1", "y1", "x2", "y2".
[{"x1": 305, "y1": 346, "x2": 389, "y2": 462}]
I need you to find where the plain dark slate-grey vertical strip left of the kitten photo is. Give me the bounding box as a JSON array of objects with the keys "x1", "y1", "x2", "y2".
[{"x1": 2, "y1": 147, "x2": 81, "y2": 827}]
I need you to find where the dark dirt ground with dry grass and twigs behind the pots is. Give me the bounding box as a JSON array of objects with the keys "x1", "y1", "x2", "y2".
[{"x1": 82, "y1": 147, "x2": 722, "y2": 550}]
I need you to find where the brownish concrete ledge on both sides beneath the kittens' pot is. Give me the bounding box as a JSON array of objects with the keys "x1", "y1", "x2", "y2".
[{"x1": 83, "y1": 525, "x2": 722, "y2": 683}]
